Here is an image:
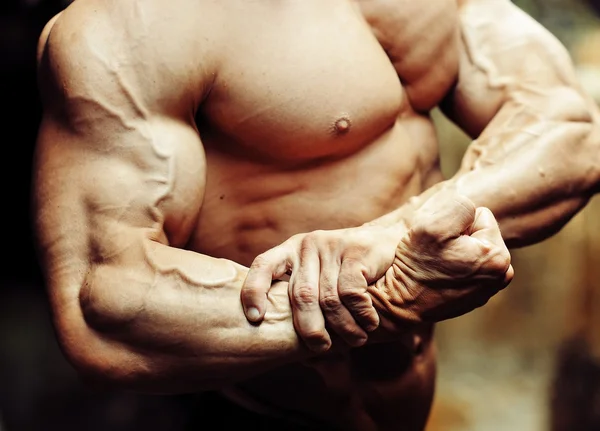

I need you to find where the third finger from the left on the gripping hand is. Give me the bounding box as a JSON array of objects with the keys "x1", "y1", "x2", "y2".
[{"x1": 319, "y1": 256, "x2": 367, "y2": 347}]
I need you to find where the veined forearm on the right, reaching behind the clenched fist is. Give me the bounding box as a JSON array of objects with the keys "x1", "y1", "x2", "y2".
[{"x1": 375, "y1": 95, "x2": 600, "y2": 247}]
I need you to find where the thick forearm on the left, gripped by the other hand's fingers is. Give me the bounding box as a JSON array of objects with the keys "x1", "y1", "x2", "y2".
[{"x1": 75, "y1": 242, "x2": 309, "y2": 393}]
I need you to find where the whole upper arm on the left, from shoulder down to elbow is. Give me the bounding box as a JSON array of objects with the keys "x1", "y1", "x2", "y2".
[{"x1": 33, "y1": 2, "x2": 213, "y2": 352}]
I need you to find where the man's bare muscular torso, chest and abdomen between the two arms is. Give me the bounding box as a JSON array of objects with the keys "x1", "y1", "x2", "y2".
[{"x1": 180, "y1": 0, "x2": 458, "y2": 424}]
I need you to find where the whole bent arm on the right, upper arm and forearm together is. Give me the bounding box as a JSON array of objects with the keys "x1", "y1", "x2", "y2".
[{"x1": 390, "y1": 0, "x2": 600, "y2": 247}]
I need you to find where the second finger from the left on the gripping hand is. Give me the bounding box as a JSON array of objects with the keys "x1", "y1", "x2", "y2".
[{"x1": 289, "y1": 238, "x2": 331, "y2": 353}]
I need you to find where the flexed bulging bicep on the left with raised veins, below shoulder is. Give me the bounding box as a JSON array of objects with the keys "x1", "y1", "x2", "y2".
[{"x1": 34, "y1": 113, "x2": 204, "y2": 286}]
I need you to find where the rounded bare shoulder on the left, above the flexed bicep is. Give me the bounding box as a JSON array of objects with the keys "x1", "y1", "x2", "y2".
[{"x1": 38, "y1": 0, "x2": 223, "y2": 116}]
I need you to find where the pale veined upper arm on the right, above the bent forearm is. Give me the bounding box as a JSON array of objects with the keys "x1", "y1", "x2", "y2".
[{"x1": 441, "y1": 0, "x2": 590, "y2": 138}]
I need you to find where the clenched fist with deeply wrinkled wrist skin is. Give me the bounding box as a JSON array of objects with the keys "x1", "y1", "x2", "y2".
[{"x1": 369, "y1": 190, "x2": 514, "y2": 324}]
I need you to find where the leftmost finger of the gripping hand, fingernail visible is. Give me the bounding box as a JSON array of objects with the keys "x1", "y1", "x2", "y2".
[{"x1": 241, "y1": 245, "x2": 291, "y2": 322}]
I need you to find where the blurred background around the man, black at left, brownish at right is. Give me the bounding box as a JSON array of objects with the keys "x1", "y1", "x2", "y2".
[{"x1": 0, "y1": 0, "x2": 600, "y2": 431}]
